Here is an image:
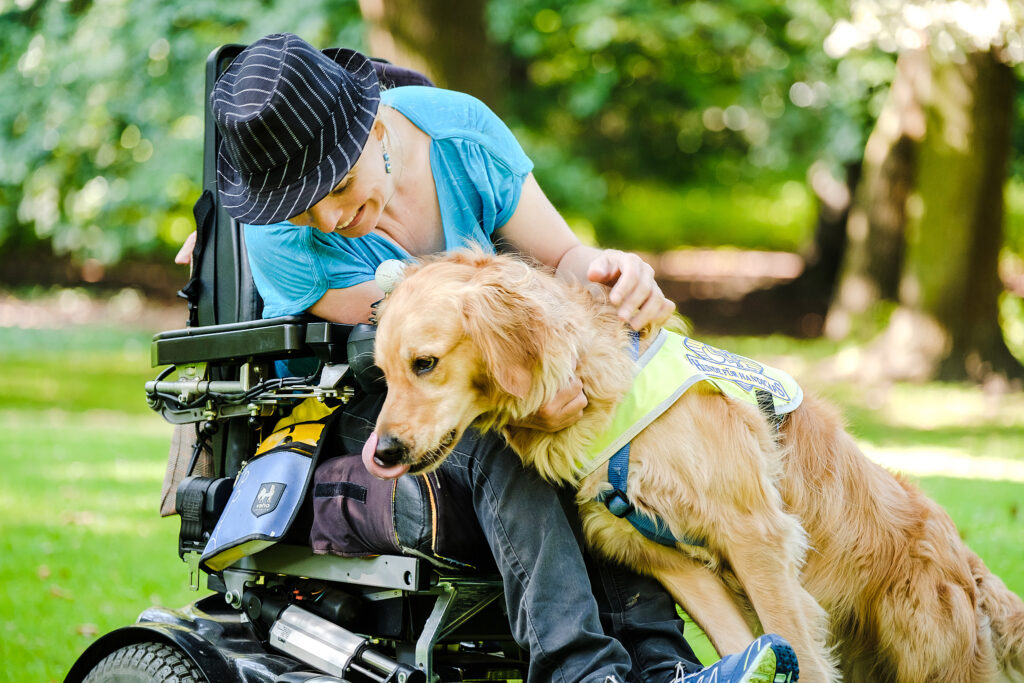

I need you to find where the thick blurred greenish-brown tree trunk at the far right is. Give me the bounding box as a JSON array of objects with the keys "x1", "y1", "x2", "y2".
[{"x1": 893, "y1": 52, "x2": 1024, "y2": 380}]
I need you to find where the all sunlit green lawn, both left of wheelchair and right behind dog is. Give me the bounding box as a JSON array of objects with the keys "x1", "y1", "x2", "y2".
[{"x1": 0, "y1": 327, "x2": 1024, "y2": 683}]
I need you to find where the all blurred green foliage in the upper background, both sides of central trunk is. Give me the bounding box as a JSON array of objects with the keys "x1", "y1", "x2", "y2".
[{"x1": 0, "y1": 0, "x2": 1024, "y2": 263}]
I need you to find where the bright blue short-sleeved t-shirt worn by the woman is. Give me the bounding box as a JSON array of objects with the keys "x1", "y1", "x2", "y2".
[{"x1": 245, "y1": 86, "x2": 534, "y2": 317}]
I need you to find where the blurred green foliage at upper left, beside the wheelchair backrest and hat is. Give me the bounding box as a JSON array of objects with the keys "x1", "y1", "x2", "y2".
[{"x1": 0, "y1": 0, "x2": 361, "y2": 263}]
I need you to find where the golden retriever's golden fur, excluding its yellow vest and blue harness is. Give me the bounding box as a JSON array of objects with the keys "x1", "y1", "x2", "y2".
[{"x1": 376, "y1": 251, "x2": 1024, "y2": 683}]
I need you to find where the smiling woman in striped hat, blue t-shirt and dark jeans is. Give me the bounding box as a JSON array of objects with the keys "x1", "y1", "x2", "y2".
[{"x1": 203, "y1": 34, "x2": 796, "y2": 682}]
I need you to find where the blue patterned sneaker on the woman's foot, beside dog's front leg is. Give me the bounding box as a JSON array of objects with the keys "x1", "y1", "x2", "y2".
[{"x1": 673, "y1": 634, "x2": 800, "y2": 683}]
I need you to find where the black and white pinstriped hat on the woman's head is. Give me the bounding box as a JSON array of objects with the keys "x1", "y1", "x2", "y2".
[{"x1": 210, "y1": 33, "x2": 380, "y2": 225}]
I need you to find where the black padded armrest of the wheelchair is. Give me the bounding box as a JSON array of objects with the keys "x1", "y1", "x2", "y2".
[{"x1": 152, "y1": 315, "x2": 352, "y2": 368}]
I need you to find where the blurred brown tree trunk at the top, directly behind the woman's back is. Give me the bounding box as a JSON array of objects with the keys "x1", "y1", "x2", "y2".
[{"x1": 359, "y1": 0, "x2": 506, "y2": 111}]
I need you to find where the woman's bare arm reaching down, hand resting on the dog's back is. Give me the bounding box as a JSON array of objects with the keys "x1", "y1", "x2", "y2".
[{"x1": 498, "y1": 173, "x2": 676, "y2": 330}]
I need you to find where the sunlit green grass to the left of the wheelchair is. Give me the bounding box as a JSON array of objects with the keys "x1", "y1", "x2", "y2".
[{"x1": 0, "y1": 328, "x2": 203, "y2": 683}]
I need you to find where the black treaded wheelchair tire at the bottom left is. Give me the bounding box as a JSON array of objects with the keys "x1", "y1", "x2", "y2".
[{"x1": 83, "y1": 643, "x2": 206, "y2": 683}]
